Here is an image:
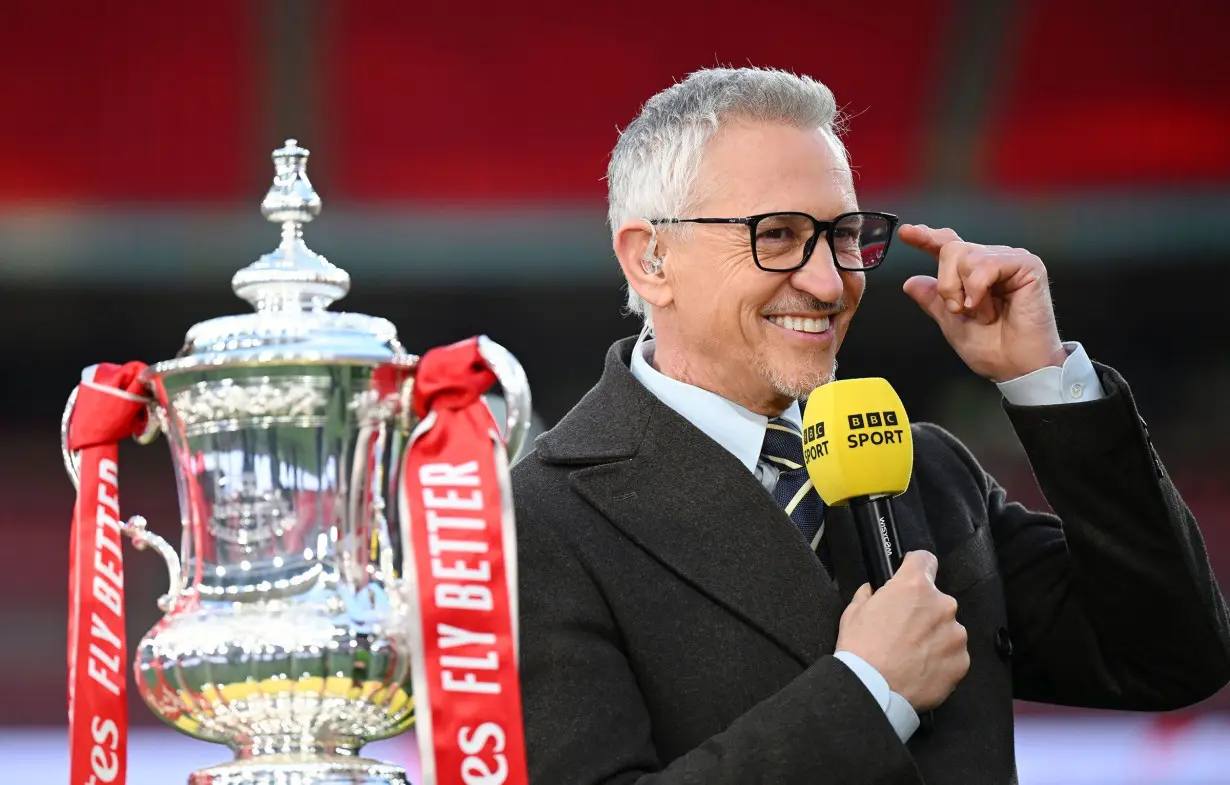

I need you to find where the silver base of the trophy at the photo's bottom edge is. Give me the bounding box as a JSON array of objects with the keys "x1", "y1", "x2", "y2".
[{"x1": 188, "y1": 754, "x2": 408, "y2": 785}]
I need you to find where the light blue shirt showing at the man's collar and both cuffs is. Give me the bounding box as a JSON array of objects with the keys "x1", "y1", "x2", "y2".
[{"x1": 631, "y1": 333, "x2": 1106, "y2": 743}]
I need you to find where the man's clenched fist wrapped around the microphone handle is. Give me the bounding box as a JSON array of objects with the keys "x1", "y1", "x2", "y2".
[{"x1": 838, "y1": 551, "x2": 969, "y2": 714}]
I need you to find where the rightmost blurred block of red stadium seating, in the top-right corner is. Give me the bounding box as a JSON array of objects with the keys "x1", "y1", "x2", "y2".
[{"x1": 984, "y1": 0, "x2": 1230, "y2": 191}]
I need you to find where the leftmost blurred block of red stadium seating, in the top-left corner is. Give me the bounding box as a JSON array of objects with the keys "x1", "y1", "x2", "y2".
[{"x1": 0, "y1": 0, "x2": 255, "y2": 203}]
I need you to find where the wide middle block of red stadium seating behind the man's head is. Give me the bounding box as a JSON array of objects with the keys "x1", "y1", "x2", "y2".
[{"x1": 323, "y1": 0, "x2": 950, "y2": 202}]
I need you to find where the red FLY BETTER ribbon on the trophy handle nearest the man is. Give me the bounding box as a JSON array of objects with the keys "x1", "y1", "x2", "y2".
[{"x1": 402, "y1": 338, "x2": 529, "y2": 785}]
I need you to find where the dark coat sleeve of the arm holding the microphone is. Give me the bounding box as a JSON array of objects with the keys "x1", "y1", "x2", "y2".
[{"x1": 517, "y1": 470, "x2": 923, "y2": 785}]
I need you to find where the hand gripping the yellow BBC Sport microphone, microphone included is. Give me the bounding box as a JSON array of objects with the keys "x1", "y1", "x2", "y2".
[{"x1": 803, "y1": 379, "x2": 969, "y2": 714}]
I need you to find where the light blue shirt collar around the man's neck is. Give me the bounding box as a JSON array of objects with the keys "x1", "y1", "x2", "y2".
[{"x1": 631, "y1": 340, "x2": 803, "y2": 471}]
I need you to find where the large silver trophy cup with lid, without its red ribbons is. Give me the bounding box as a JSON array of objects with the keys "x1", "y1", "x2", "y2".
[{"x1": 62, "y1": 139, "x2": 531, "y2": 785}]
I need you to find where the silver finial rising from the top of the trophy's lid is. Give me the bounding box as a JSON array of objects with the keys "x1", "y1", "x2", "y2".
[{"x1": 231, "y1": 139, "x2": 351, "y2": 311}]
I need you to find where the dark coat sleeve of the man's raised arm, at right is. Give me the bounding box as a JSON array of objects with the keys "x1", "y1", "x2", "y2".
[{"x1": 935, "y1": 365, "x2": 1230, "y2": 711}]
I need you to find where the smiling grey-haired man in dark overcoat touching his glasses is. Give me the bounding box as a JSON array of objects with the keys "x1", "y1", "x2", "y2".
[{"x1": 513, "y1": 69, "x2": 1230, "y2": 785}]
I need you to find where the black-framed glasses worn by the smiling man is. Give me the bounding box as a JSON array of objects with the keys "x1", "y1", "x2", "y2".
[{"x1": 649, "y1": 213, "x2": 897, "y2": 273}]
